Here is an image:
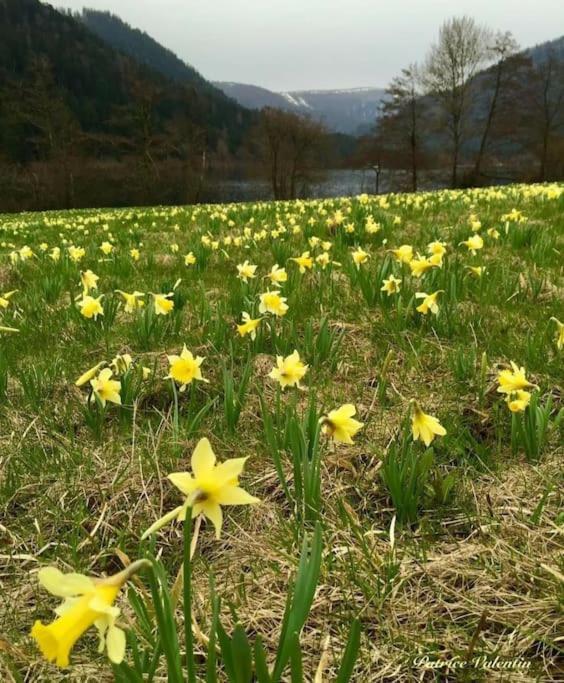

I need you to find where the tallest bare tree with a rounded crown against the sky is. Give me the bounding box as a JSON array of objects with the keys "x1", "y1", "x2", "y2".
[{"x1": 424, "y1": 16, "x2": 490, "y2": 187}]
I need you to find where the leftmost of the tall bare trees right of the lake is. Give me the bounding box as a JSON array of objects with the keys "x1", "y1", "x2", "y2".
[{"x1": 379, "y1": 64, "x2": 423, "y2": 192}]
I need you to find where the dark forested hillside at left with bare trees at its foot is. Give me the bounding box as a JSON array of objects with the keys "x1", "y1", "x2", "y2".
[{"x1": 0, "y1": 0, "x2": 254, "y2": 208}]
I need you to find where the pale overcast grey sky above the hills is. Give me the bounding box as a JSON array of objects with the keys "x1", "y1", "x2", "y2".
[{"x1": 54, "y1": 0, "x2": 564, "y2": 90}]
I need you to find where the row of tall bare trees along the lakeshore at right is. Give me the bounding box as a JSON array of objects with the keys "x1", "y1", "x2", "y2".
[{"x1": 371, "y1": 16, "x2": 564, "y2": 190}]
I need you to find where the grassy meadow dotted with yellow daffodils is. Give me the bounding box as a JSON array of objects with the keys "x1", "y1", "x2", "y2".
[{"x1": 0, "y1": 185, "x2": 564, "y2": 682}]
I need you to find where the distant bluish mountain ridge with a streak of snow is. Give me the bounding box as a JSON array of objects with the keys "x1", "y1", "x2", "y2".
[{"x1": 214, "y1": 81, "x2": 386, "y2": 135}]
